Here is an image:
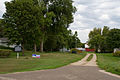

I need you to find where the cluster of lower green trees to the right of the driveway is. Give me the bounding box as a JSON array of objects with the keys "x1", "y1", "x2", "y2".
[{"x1": 88, "y1": 26, "x2": 120, "y2": 52}]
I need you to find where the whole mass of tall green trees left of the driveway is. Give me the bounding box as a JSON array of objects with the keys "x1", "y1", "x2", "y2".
[{"x1": 3, "y1": 0, "x2": 81, "y2": 53}]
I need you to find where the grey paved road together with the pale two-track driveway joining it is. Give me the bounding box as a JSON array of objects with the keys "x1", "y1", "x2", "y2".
[{"x1": 0, "y1": 54, "x2": 120, "y2": 80}]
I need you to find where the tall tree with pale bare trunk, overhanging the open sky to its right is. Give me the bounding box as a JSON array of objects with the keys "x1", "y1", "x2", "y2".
[{"x1": 38, "y1": 0, "x2": 76, "y2": 52}]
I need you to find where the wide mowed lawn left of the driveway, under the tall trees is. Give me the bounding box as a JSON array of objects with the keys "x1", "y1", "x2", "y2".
[{"x1": 0, "y1": 52, "x2": 86, "y2": 74}]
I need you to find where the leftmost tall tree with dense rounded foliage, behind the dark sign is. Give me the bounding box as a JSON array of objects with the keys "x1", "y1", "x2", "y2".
[{"x1": 3, "y1": 0, "x2": 40, "y2": 55}]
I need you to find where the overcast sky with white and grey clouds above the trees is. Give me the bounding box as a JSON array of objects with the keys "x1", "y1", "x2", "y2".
[{"x1": 0, "y1": 0, "x2": 120, "y2": 42}]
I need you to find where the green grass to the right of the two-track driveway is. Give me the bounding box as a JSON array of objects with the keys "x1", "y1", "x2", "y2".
[{"x1": 97, "y1": 53, "x2": 120, "y2": 75}]
